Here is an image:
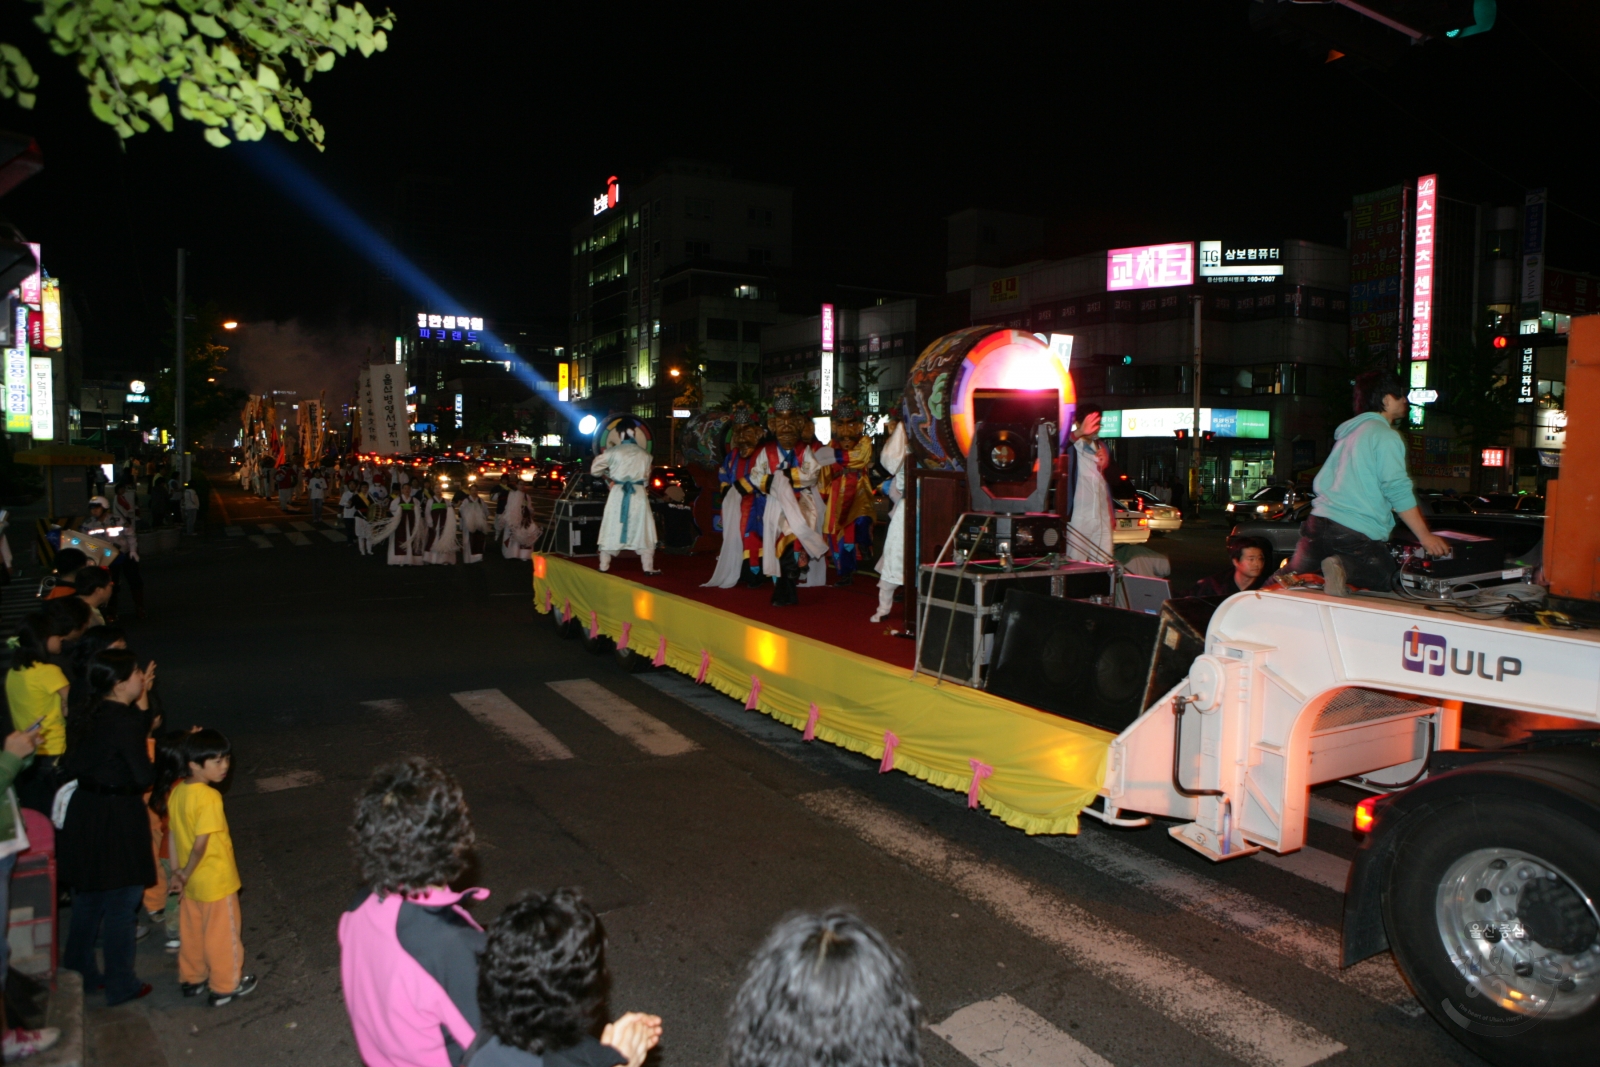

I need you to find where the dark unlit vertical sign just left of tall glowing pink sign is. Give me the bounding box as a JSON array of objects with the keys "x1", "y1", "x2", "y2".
[{"x1": 1350, "y1": 186, "x2": 1405, "y2": 370}]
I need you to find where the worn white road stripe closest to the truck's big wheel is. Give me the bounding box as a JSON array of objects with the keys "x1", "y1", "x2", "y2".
[{"x1": 1035, "y1": 830, "x2": 1422, "y2": 1016}]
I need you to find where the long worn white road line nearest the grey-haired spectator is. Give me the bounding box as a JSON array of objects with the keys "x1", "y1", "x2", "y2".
[{"x1": 798, "y1": 789, "x2": 1344, "y2": 1067}]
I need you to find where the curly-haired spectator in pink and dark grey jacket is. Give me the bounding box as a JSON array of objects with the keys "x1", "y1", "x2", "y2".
[{"x1": 339, "y1": 758, "x2": 488, "y2": 1067}]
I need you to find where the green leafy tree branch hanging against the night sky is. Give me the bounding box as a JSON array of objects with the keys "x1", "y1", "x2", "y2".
[{"x1": 0, "y1": 0, "x2": 395, "y2": 152}]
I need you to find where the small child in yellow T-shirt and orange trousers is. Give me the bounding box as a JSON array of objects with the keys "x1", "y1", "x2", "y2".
[{"x1": 166, "y1": 729, "x2": 256, "y2": 1008}]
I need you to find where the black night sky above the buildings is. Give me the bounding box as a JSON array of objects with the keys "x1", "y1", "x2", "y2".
[{"x1": 0, "y1": 0, "x2": 1600, "y2": 387}]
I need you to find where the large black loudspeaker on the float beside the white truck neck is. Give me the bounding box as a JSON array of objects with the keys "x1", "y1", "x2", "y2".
[{"x1": 986, "y1": 590, "x2": 1214, "y2": 733}]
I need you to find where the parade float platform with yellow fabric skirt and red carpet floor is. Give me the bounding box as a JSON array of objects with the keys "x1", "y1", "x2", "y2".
[{"x1": 533, "y1": 553, "x2": 1112, "y2": 833}]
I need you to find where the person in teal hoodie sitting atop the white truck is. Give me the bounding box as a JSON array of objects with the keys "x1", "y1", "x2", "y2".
[{"x1": 1290, "y1": 371, "x2": 1450, "y2": 597}]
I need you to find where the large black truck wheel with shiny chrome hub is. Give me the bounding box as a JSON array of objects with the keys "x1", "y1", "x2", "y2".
[{"x1": 1384, "y1": 793, "x2": 1600, "y2": 1067}]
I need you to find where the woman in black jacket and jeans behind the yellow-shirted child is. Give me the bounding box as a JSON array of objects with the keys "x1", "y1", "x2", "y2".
[{"x1": 56, "y1": 648, "x2": 155, "y2": 1005}]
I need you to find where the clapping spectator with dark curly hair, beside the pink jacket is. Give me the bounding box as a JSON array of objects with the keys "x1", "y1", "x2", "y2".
[{"x1": 467, "y1": 889, "x2": 661, "y2": 1067}]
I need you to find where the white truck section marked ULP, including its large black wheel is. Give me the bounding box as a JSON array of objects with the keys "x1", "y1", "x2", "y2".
[{"x1": 1098, "y1": 534, "x2": 1600, "y2": 1065}]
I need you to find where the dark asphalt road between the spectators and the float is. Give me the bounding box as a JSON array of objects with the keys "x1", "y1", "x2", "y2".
[{"x1": 91, "y1": 493, "x2": 1478, "y2": 1067}]
